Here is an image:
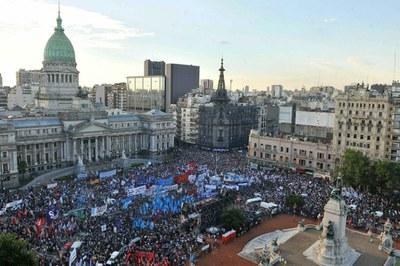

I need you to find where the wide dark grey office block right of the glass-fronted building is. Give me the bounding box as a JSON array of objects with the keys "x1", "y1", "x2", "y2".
[{"x1": 165, "y1": 64, "x2": 200, "y2": 108}]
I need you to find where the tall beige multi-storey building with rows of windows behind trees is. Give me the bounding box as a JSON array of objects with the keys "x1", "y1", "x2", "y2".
[{"x1": 333, "y1": 86, "x2": 393, "y2": 160}]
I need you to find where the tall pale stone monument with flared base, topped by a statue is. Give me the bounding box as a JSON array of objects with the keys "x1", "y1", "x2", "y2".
[{"x1": 303, "y1": 178, "x2": 360, "y2": 266}]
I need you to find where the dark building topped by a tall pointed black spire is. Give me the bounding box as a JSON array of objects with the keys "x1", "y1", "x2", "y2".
[{"x1": 198, "y1": 60, "x2": 258, "y2": 150}]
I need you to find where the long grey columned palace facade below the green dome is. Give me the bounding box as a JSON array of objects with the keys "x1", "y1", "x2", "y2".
[{"x1": 0, "y1": 110, "x2": 176, "y2": 186}]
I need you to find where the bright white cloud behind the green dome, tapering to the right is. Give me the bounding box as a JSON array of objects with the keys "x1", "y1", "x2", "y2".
[{"x1": 0, "y1": 0, "x2": 154, "y2": 85}]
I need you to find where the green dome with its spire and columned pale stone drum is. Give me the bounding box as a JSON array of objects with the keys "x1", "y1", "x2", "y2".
[{"x1": 37, "y1": 10, "x2": 79, "y2": 110}]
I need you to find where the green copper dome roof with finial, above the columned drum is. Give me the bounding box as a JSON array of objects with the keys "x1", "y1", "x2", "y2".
[{"x1": 44, "y1": 13, "x2": 76, "y2": 64}]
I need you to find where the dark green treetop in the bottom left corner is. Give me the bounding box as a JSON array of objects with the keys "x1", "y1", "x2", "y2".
[{"x1": 0, "y1": 233, "x2": 38, "y2": 266}]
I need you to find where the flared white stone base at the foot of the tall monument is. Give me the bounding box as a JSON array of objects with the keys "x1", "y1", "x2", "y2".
[{"x1": 303, "y1": 240, "x2": 361, "y2": 266}]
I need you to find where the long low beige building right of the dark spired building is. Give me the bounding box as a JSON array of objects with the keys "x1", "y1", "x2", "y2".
[{"x1": 248, "y1": 130, "x2": 335, "y2": 173}]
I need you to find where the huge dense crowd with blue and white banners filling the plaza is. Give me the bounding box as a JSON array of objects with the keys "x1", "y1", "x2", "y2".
[{"x1": 0, "y1": 149, "x2": 400, "y2": 266}]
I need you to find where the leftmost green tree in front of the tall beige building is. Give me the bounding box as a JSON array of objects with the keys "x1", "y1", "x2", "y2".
[{"x1": 339, "y1": 149, "x2": 373, "y2": 189}]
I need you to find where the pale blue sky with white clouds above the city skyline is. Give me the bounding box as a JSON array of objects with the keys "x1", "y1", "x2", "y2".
[{"x1": 0, "y1": 0, "x2": 400, "y2": 90}]
